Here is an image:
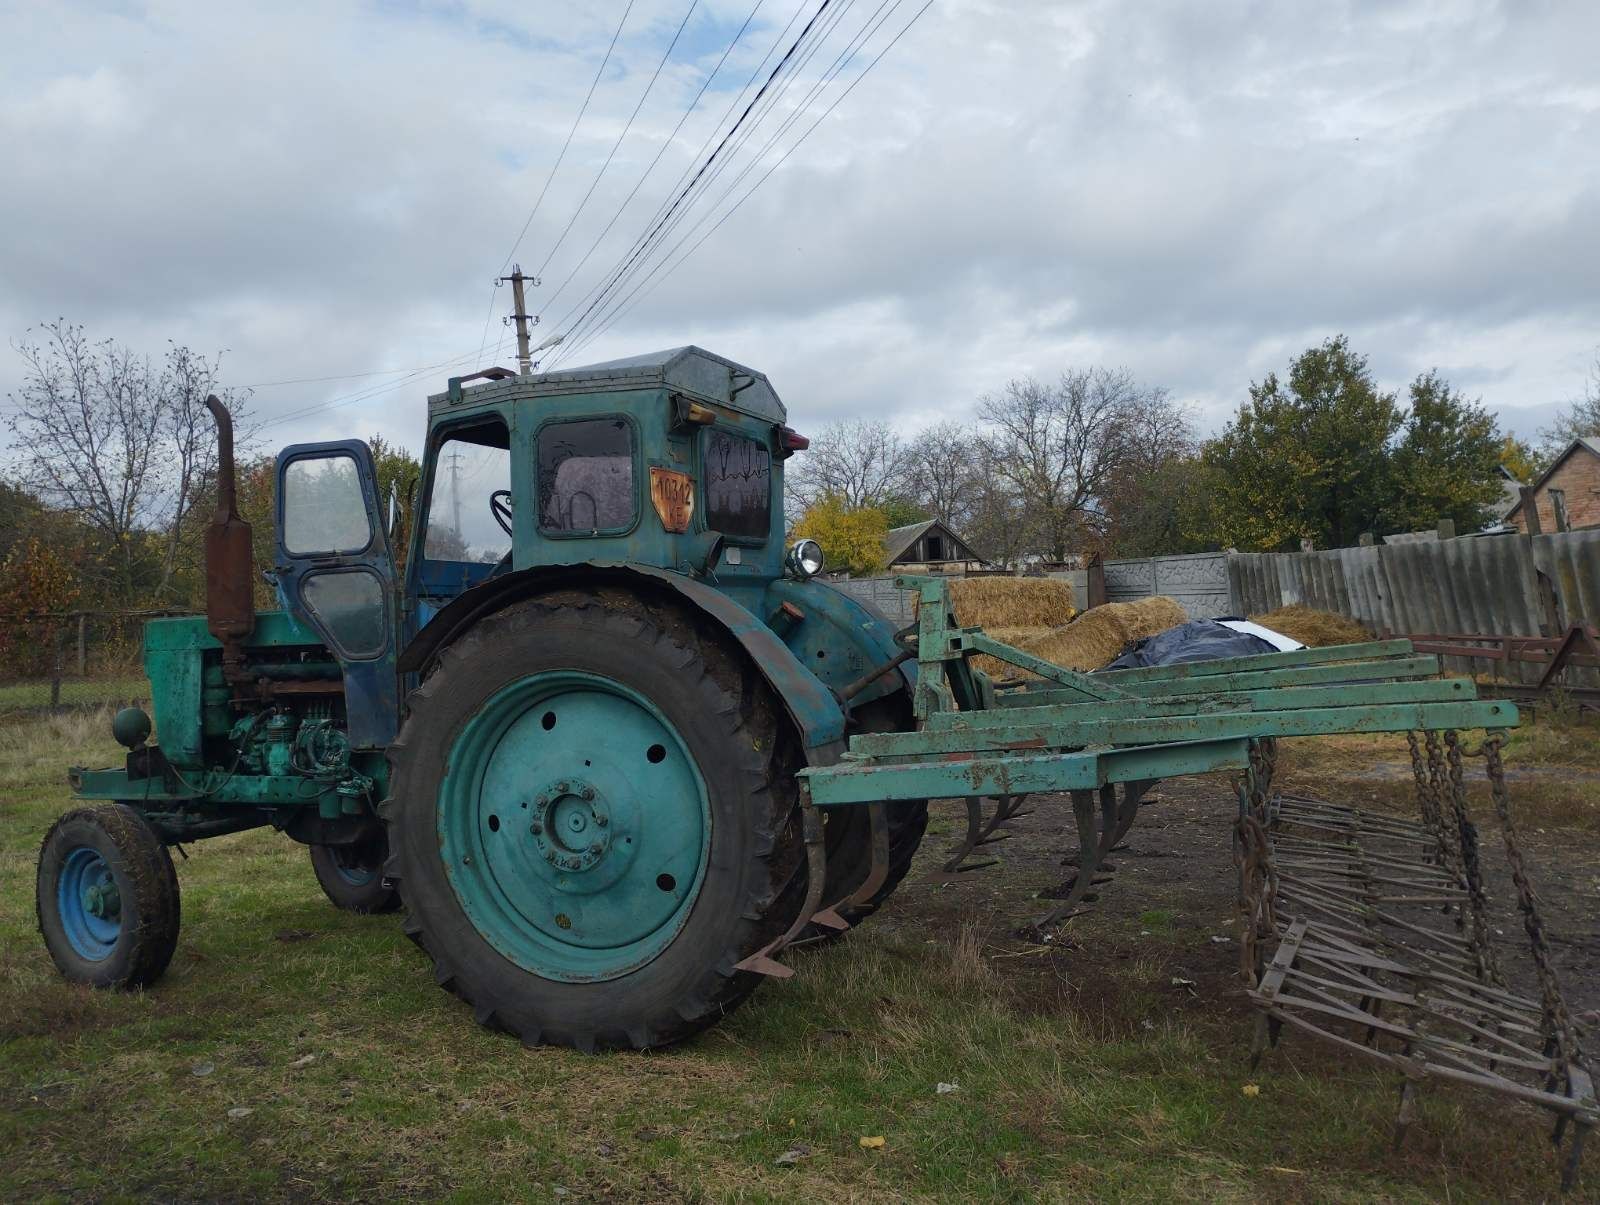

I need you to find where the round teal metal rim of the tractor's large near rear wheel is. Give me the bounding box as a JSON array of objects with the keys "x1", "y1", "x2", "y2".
[{"x1": 438, "y1": 671, "x2": 710, "y2": 983}]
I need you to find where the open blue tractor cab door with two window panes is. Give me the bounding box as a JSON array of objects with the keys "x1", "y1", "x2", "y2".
[{"x1": 275, "y1": 440, "x2": 400, "y2": 749}]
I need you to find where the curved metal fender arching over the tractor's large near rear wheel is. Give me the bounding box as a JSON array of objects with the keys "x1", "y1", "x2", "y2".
[{"x1": 398, "y1": 562, "x2": 845, "y2": 765}]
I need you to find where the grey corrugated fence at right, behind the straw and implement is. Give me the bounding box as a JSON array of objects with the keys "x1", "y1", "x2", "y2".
[{"x1": 1227, "y1": 530, "x2": 1600, "y2": 685}]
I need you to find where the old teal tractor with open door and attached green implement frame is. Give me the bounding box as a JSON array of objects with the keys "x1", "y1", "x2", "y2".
[{"x1": 37, "y1": 347, "x2": 1517, "y2": 1050}]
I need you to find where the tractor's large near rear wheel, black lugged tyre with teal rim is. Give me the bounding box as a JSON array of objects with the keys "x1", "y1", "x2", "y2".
[{"x1": 382, "y1": 590, "x2": 805, "y2": 1050}]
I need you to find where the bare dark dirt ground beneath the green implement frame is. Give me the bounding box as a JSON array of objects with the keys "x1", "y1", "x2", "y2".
[{"x1": 870, "y1": 762, "x2": 1600, "y2": 1048}]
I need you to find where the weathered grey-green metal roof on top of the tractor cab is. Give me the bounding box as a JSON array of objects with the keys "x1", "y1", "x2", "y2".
[{"x1": 427, "y1": 346, "x2": 787, "y2": 422}]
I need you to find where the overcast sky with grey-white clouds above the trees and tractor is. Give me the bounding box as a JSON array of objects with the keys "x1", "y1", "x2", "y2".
[{"x1": 0, "y1": 0, "x2": 1600, "y2": 448}]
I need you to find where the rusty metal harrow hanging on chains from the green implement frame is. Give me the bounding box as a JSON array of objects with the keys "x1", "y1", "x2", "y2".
[{"x1": 1235, "y1": 730, "x2": 1600, "y2": 1189}]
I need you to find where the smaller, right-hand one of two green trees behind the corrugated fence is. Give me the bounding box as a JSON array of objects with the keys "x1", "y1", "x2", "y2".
[{"x1": 1384, "y1": 368, "x2": 1504, "y2": 531}]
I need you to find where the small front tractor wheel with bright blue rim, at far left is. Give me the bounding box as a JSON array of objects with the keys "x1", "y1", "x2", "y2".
[{"x1": 35, "y1": 803, "x2": 179, "y2": 987}]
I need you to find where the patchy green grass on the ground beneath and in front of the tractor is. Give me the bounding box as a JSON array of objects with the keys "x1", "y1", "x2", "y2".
[{"x1": 0, "y1": 714, "x2": 1594, "y2": 1200}]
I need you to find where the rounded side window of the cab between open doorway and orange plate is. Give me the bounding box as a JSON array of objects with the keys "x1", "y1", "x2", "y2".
[{"x1": 539, "y1": 418, "x2": 635, "y2": 534}]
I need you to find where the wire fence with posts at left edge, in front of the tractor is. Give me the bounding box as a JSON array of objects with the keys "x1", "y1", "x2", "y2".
[{"x1": 0, "y1": 611, "x2": 186, "y2": 717}]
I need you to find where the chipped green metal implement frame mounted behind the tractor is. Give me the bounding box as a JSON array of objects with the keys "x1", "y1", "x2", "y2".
[{"x1": 802, "y1": 578, "x2": 1517, "y2": 807}]
